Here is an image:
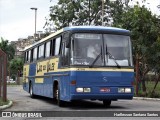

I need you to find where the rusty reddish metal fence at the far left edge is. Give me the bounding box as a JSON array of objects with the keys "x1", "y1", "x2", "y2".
[{"x1": 0, "y1": 49, "x2": 7, "y2": 102}]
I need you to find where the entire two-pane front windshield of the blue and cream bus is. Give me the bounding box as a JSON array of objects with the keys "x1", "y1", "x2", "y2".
[{"x1": 71, "y1": 33, "x2": 132, "y2": 66}]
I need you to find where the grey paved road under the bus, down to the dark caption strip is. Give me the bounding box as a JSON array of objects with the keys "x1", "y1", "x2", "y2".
[{"x1": 1, "y1": 86, "x2": 160, "y2": 120}]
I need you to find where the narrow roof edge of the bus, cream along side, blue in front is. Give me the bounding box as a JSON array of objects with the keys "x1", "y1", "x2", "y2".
[{"x1": 24, "y1": 26, "x2": 130, "y2": 51}]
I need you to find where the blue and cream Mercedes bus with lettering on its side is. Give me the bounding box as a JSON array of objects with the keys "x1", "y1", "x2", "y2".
[{"x1": 23, "y1": 26, "x2": 134, "y2": 106}]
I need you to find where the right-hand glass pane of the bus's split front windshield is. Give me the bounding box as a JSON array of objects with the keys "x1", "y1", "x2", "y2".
[{"x1": 104, "y1": 34, "x2": 132, "y2": 66}]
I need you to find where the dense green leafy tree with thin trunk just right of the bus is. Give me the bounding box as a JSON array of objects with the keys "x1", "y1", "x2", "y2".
[{"x1": 113, "y1": 5, "x2": 159, "y2": 92}]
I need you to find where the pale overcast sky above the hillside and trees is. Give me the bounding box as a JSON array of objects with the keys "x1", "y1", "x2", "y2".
[{"x1": 0, "y1": 0, "x2": 160, "y2": 41}]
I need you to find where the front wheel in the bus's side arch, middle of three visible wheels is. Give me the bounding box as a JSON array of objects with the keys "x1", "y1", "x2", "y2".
[{"x1": 55, "y1": 86, "x2": 65, "y2": 107}]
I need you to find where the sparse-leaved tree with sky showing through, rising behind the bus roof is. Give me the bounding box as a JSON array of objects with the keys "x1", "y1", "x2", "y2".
[{"x1": 45, "y1": 0, "x2": 113, "y2": 30}]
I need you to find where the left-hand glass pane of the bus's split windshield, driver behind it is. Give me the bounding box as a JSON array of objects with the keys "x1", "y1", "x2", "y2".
[{"x1": 71, "y1": 33, "x2": 104, "y2": 66}]
